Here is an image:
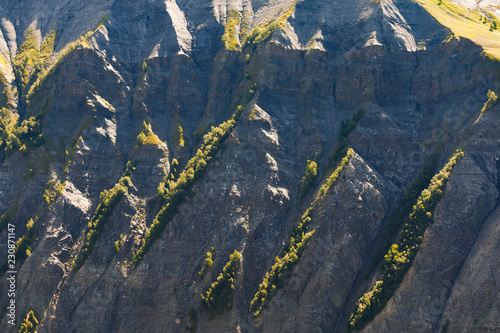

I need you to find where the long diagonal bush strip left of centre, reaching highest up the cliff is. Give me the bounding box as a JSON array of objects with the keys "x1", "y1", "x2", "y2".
[{"x1": 132, "y1": 87, "x2": 255, "y2": 267}]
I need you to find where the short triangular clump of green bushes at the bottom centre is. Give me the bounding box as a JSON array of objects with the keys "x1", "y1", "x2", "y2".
[{"x1": 201, "y1": 250, "x2": 241, "y2": 314}]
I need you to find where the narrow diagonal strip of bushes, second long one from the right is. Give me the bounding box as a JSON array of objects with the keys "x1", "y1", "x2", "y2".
[{"x1": 250, "y1": 148, "x2": 354, "y2": 317}]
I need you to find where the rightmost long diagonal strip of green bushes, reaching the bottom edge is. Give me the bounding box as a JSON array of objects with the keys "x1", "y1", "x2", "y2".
[{"x1": 347, "y1": 150, "x2": 464, "y2": 332}]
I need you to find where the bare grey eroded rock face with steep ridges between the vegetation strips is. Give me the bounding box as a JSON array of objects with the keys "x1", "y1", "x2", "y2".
[{"x1": 0, "y1": 0, "x2": 500, "y2": 332}]
